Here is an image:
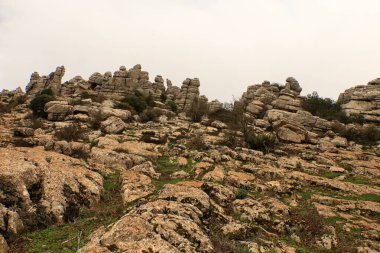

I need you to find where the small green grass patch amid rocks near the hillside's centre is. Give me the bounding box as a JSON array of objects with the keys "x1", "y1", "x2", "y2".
[{"x1": 152, "y1": 156, "x2": 194, "y2": 192}]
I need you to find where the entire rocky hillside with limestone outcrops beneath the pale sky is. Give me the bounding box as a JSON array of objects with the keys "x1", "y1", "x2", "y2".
[{"x1": 0, "y1": 65, "x2": 380, "y2": 253}]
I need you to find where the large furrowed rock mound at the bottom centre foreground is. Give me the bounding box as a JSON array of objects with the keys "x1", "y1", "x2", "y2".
[{"x1": 79, "y1": 184, "x2": 214, "y2": 253}]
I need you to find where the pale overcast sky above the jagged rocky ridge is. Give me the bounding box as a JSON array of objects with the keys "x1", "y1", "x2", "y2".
[{"x1": 0, "y1": 0, "x2": 380, "y2": 102}]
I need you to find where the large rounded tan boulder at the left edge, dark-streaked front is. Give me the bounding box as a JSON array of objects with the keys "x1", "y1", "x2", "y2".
[{"x1": 0, "y1": 147, "x2": 102, "y2": 233}]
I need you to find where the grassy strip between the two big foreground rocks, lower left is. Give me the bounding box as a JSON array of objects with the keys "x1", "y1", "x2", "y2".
[{"x1": 10, "y1": 170, "x2": 124, "y2": 253}]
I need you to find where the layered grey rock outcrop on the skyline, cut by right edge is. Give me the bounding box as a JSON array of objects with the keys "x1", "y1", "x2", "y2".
[{"x1": 338, "y1": 78, "x2": 380, "y2": 123}]
